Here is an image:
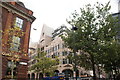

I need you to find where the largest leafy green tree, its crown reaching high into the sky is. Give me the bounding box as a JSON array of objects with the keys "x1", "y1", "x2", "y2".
[{"x1": 62, "y1": 2, "x2": 119, "y2": 80}]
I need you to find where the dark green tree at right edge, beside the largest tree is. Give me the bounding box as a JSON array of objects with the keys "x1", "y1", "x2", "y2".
[{"x1": 100, "y1": 40, "x2": 120, "y2": 79}]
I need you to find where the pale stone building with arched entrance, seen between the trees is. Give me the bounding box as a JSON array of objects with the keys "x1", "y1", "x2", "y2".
[{"x1": 29, "y1": 25, "x2": 91, "y2": 78}]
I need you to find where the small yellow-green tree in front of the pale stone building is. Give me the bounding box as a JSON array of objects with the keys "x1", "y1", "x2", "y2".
[{"x1": 30, "y1": 49, "x2": 58, "y2": 76}]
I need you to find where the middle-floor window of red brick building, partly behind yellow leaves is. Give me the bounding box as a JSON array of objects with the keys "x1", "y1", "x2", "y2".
[{"x1": 10, "y1": 36, "x2": 20, "y2": 51}]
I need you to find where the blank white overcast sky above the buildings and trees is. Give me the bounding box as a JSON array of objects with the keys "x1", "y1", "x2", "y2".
[{"x1": 20, "y1": 0, "x2": 118, "y2": 42}]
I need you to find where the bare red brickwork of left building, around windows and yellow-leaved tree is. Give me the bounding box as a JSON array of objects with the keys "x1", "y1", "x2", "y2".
[{"x1": 2, "y1": 3, "x2": 35, "y2": 78}]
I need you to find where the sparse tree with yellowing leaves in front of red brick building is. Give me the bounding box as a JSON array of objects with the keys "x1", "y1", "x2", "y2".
[{"x1": 0, "y1": 26, "x2": 27, "y2": 78}]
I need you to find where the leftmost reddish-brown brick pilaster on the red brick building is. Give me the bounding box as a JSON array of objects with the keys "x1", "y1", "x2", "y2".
[{"x1": 2, "y1": 11, "x2": 13, "y2": 77}]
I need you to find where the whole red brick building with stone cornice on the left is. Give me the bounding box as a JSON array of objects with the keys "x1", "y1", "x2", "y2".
[{"x1": 0, "y1": 2, "x2": 35, "y2": 78}]
